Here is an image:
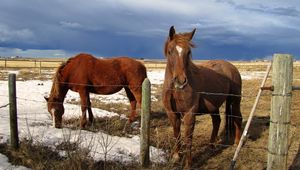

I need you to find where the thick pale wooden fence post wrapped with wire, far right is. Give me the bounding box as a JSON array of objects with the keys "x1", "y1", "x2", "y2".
[{"x1": 267, "y1": 54, "x2": 293, "y2": 170}]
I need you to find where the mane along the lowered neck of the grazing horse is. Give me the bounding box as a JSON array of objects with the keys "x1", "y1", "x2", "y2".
[{"x1": 50, "y1": 57, "x2": 73, "y2": 98}]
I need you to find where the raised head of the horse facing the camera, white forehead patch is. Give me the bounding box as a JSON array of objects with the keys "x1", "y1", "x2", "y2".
[{"x1": 164, "y1": 26, "x2": 196, "y2": 89}]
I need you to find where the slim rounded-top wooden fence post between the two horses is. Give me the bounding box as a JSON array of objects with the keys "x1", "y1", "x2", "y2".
[{"x1": 140, "y1": 78, "x2": 151, "y2": 167}]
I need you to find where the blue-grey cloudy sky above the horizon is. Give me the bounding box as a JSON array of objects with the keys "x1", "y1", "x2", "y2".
[{"x1": 0, "y1": 0, "x2": 300, "y2": 60}]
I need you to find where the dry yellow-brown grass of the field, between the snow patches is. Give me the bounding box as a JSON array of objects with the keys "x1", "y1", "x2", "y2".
[{"x1": 0, "y1": 58, "x2": 300, "y2": 170}]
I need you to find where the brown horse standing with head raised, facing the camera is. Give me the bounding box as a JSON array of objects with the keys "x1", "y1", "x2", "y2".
[{"x1": 163, "y1": 26, "x2": 242, "y2": 169}]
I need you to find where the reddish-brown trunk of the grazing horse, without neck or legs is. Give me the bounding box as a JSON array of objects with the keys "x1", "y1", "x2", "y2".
[{"x1": 58, "y1": 54, "x2": 147, "y2": 94}]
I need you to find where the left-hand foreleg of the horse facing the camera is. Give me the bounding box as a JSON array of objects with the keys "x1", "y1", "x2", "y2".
[{"x1": 167, "y1": 112, "x2": 181, "y2": 162}]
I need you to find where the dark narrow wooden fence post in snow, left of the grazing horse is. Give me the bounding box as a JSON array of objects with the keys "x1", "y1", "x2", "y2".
[{"x1": 8, "y1": 74, "x2": 19, "y2": 149}]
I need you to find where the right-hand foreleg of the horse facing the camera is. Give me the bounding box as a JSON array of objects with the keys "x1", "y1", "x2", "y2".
[{"x1": 183, "y1": 112, "x2": 195, "y2": 169}]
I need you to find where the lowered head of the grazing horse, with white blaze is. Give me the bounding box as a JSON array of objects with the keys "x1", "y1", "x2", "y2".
[{"x1": 44, "y1": 97, "x2": 65, "y2": 128}]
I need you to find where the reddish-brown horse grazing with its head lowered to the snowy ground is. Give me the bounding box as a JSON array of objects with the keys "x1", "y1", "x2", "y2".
[{"x1": 45, "y1": 54, "x2": 147, "y2": 128}]
